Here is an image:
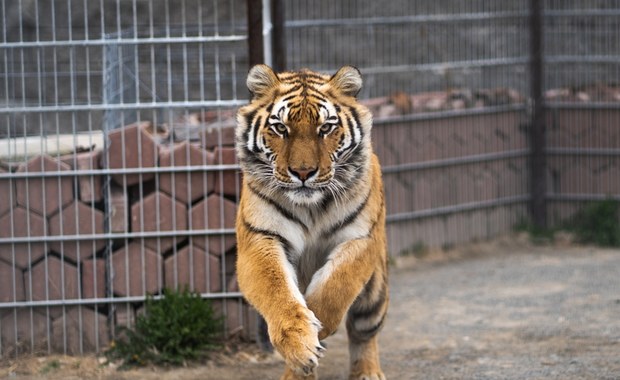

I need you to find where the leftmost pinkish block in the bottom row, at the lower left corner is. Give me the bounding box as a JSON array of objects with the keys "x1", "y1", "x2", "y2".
[{"x1": 0, "y1": 308, "x2": 51, "y2": 357}]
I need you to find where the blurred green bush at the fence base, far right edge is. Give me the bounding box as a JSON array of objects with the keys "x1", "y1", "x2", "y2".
[{"x1": 569, "y1": 199, "x2": 620, "y2": 247}]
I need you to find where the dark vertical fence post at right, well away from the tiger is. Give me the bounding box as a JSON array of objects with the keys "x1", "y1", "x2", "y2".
[{"x1": 529, "y1": 0, "x2": 547, "y2": 228}]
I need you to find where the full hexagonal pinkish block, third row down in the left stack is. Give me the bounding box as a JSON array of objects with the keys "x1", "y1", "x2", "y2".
[{"x1": 24, "y1": 256, "x2": 80, "y2": 317}]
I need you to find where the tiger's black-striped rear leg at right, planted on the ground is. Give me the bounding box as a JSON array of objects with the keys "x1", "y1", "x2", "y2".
[{"x1": 346, "y1": 272, "x2": 388, "y2": 380}]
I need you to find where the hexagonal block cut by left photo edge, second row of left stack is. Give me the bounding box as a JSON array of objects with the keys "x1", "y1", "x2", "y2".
[{"x1": 0, "y1": 207, "x2": 47, "y2": 269}]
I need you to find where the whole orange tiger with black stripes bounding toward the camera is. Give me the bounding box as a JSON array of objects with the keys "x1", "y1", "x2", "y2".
[{"x1": 235, "y1": 65, "x2": 389, "y2": 380}]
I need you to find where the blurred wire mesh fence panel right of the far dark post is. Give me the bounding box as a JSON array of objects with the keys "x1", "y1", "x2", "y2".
[{"x1": 544, "y1": 0, "x2": 620, "y2": 225}]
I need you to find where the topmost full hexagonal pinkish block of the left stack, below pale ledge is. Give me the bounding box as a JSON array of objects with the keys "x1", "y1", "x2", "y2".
[{"x1": 15, "y1": 156, "x2": 73, "y2": 216}]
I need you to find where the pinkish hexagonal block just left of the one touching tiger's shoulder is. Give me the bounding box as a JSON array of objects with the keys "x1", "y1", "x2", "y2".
[{"x1": 131, "y1": 191, "x2": 187, "y2": 253}]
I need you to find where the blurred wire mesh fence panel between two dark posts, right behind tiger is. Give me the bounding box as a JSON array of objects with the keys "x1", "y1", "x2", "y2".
[{"x1": 286, "y1": 0, "x2": 529, "y2": 254}]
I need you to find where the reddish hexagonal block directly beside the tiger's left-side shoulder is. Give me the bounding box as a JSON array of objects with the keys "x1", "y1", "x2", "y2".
[{"x1": 190, "y1": 194, "x2": 237, "y2": 256}]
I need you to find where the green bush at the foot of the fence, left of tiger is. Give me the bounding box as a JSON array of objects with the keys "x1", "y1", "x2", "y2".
[{"x1": 106, "y1": 289, "x2": 222, "y2": 368}]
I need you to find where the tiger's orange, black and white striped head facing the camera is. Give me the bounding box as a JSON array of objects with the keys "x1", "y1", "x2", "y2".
[{"x1": 236, "y1": 65, "x2": 372, "y2": 205}]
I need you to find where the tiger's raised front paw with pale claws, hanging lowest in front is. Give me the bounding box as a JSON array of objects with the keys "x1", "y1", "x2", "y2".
[{"x1": 270, "y1": 309, "x2": 325, "y2": 376}]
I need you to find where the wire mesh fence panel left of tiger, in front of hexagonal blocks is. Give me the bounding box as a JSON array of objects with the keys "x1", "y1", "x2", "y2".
[{"x1": 0, "y1": 0, "x2": 254, "y2": 357}]
